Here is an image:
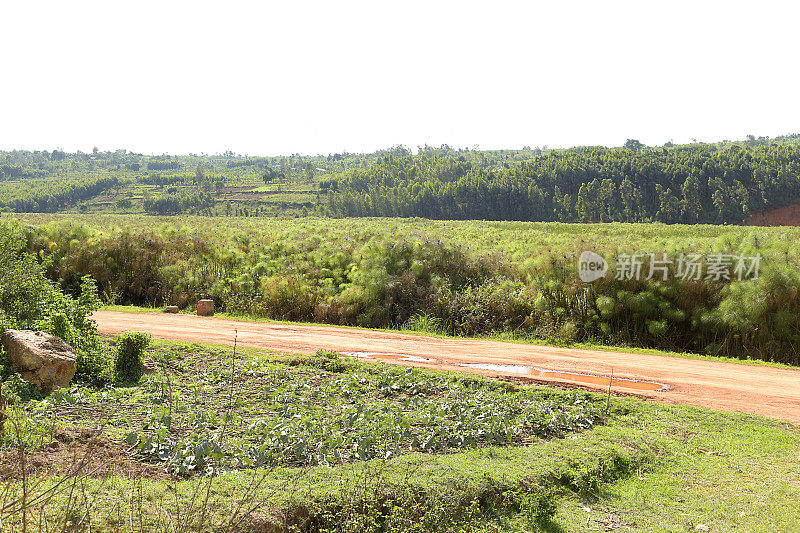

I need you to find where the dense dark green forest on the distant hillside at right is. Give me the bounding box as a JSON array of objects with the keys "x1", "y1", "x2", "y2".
[{"x1": 326, "y1": 140, "x2": 800, "y2": 224}]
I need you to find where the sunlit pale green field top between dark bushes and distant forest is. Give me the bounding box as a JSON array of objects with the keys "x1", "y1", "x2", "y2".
[{"x1": 10, "y1": 214, "x2": 800, "y2": 264}]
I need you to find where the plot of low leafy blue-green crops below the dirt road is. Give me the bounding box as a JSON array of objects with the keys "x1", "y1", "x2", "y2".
[{"x1": 120, "y1": 344, "x2": 600, "y2": 475}]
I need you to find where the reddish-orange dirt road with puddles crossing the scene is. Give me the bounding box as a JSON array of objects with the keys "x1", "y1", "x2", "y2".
[{"x1": 93, "y1": 311, "x2": 800, "y2": 424}]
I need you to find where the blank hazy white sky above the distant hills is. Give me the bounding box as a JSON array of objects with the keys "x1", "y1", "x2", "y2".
[{"x1": 0, "y1": 0, "x2": 800, "y2": 155}]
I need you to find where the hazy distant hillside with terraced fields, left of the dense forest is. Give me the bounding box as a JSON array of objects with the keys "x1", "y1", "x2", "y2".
[{"x1": 0, "y1": 148, "x2": 438, "y2": 216}]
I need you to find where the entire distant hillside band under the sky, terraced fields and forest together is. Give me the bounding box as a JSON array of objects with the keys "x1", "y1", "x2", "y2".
[{"x1": 6, "y1": 135, "x2": 800, "y2": 224}]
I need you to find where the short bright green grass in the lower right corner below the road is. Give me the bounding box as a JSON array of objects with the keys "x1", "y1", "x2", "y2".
[{"x1": 524, "y1": 408, "x2": 800, "y2": 532}]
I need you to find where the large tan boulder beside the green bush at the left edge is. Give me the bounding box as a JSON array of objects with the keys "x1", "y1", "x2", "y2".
[{"x1": 3, "y1": 329, "x2": 77, "y2": 394}]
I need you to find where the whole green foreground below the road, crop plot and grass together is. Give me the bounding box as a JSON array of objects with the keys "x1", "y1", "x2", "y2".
[{"x1": 0, "y1": 342, "x2": 800, "y2": 532}]
